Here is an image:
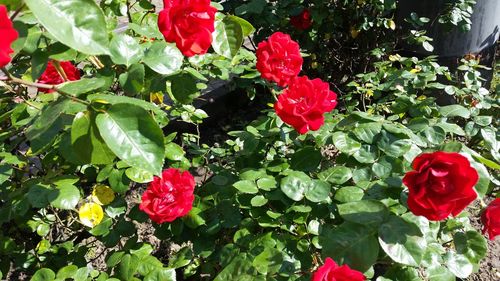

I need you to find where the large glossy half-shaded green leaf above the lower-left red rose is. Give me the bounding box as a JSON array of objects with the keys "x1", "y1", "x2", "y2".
[{"x1": 96, "y1": 103, "x2": 165, "y2": 175}]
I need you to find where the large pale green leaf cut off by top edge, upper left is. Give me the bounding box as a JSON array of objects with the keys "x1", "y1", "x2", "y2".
[{"x1": 25, "y1": 0, "x2": 109, "y2": 55}]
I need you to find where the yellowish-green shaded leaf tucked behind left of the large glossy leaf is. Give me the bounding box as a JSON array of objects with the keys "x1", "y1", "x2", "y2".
[{"x1": 71, "y1": 112, "x2": 115, "y2": 165}]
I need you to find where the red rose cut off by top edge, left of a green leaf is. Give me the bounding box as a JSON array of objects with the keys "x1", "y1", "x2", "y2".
[{"x1": 158, "y1": 0, "x2": 217, "y2": 57}]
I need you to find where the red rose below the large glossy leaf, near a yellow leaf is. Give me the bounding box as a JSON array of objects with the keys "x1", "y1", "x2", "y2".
[{"x1": 139, "y1": 168, "x2": 194, "y2": 223}]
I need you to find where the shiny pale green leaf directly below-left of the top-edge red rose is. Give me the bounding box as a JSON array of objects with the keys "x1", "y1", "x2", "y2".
[{"x1": 143, "y1": 41, "x2": 184, "y2": 75}]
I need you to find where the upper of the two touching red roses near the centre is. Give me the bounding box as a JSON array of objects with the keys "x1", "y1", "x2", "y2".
[{"x1": 257, "y1": 32, "x2": 303, "y2": 87}]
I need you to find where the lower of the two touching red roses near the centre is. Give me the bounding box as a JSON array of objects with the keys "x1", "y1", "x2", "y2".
[{"x1": 274, "y1": 76, "x2": 337, "y2": 134}]
